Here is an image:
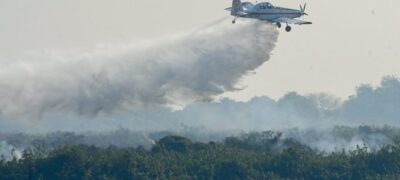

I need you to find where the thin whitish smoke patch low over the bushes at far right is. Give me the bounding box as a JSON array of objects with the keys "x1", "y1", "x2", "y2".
[{"x1": 284, "y1": 126, "x2": 399, "y2": 152}]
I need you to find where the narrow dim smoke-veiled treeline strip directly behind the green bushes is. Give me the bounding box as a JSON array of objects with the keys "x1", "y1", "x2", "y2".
[{"x1": 0, "y1": 126, "x2": 400, "y2": 153}]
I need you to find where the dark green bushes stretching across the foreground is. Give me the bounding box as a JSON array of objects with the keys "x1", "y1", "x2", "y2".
[{"x1": 0, "y1": 132, "x2": 400, "y2": 179}]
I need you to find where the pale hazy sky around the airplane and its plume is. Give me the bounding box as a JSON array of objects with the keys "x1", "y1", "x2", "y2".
[{"x1": 0, "y1": 0, "x2": 400, "y2": 99}]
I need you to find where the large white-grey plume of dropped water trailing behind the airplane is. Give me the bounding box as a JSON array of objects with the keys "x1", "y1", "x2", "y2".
[{"x1": 0, "y1": 21, "x2": 278, "y2": 118}]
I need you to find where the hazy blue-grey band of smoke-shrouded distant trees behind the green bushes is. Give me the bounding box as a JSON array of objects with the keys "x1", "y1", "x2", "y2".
[{"x1": 0, "y1": 77, "x2": 400, "y2": 155}]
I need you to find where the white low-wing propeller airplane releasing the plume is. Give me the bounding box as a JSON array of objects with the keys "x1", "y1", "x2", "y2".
[{"x1": 225, "y1": 0, "x2": 312, "y2": 32}]
